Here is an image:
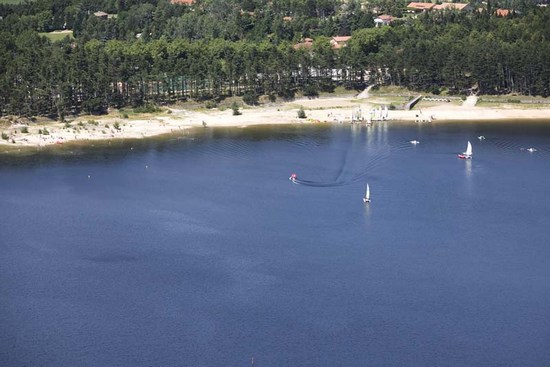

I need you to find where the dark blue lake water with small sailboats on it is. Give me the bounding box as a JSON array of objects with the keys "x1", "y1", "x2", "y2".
[{"x1": 0, "y1": 122, "x2": 550, "y2": 366}]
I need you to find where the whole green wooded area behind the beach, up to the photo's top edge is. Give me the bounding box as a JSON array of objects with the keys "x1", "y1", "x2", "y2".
[{"x1": 0, "y1": 0, "x2": 550, "y2": 119}]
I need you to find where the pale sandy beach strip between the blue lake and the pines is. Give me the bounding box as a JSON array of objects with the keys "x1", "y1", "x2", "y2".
[{"x1": 0, "y1": 96, "x2": 550, "y2": 147}]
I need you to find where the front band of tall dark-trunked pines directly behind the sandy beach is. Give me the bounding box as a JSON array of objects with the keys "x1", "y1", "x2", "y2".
[{"x1": 0, "y1": 0, "x2": 550, "y2": 118}]
